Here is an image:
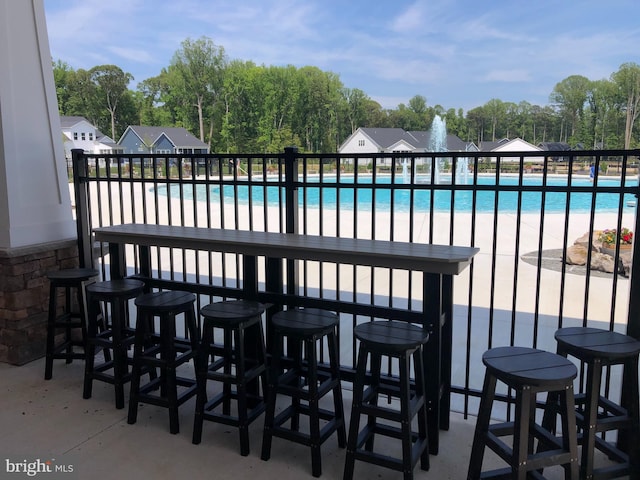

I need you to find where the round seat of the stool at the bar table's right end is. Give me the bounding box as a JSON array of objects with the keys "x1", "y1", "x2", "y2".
[{"x1": 353, "y1": 320, "x2": 429, "y2": 351}]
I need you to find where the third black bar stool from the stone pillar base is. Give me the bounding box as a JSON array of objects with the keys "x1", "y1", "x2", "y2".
[{"x1": 127, "y1": 290, "x2": 195, "y2": 434}]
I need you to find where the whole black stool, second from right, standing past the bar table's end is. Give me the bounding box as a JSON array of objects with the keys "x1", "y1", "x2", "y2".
[{"x1": 467, "y1": 347, "x2": 578, "y2": 480}]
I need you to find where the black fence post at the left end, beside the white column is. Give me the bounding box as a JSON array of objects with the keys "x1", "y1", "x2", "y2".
[{"x1": 71, "y1": 148, "x2": 94, "y2": 268}]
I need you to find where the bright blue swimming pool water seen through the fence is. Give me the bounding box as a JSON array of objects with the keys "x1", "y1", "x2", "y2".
[{"x1": 159, "y1": 177, "x2": 637, "y2": 212}]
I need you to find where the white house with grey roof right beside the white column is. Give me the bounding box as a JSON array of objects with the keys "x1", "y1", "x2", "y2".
[{"x1": 60, "y1": 115, "x2": 122, "y2": 161}]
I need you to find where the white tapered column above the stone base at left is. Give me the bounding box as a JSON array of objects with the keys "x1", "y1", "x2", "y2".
[{"x1": 0, "y1": 0, "x2": 76, "y2": 249}]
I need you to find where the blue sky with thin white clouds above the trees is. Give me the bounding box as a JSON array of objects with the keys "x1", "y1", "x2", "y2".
[{"x1": 44, "y1": 0, "x2": 640, "y2": 111}]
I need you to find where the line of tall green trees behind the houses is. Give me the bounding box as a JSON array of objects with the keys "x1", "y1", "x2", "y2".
[{"x1": 53, "y1": 37, "x2": 640, "y2": 153}]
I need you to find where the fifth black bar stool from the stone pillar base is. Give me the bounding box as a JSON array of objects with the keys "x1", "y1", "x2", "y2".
[{"x1": 261, "y1": 308, "x2": 346, "y2": 477}]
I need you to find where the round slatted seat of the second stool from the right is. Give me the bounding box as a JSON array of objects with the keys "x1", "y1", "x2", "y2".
[{"x1": 482, "y1": 347, "x2": 578, "y2": 387}]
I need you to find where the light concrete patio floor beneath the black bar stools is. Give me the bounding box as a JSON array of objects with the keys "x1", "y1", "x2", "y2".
[{"x1": 0, "y1": 359, "x2": 596, "y2": 480}]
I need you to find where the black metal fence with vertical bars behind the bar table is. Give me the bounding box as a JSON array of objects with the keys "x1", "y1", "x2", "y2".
[{"x1": 73, "y1": 148, "x2": 640, "y2": 414}]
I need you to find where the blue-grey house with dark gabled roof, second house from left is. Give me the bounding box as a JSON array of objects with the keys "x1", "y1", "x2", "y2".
[{"x1": 118, "y1": 125, "x2": 209, "y2": 154}]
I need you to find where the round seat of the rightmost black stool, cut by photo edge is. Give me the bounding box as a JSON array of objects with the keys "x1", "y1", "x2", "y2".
[{"x1": 555, "y1": 327, "x2": 640, "y2": 361}]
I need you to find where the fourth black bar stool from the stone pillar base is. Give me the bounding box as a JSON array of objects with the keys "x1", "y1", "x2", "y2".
[{"x1": 193, "y1": 300, "x2": 267, "y2": 456}]
